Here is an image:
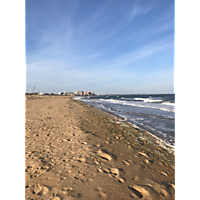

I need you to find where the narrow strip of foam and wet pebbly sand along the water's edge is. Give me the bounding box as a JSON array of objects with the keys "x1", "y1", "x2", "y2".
[{"x1": 71, "y1": 97, "x2": 175, "y2": 155}]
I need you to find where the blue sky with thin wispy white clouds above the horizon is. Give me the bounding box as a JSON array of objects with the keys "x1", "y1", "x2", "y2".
[{"x1": 25, "y1": 0, "x2": 175, "y2": 94}]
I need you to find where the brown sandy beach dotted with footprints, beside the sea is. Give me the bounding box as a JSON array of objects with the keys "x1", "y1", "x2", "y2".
[{"x1": 25, "y1": 96, "x2": 175, "y2": 200}]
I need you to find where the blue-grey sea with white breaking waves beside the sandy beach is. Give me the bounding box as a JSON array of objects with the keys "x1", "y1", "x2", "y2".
[{"x1": 74, "y1": 94, "x2": 175, "y2": 146}]
